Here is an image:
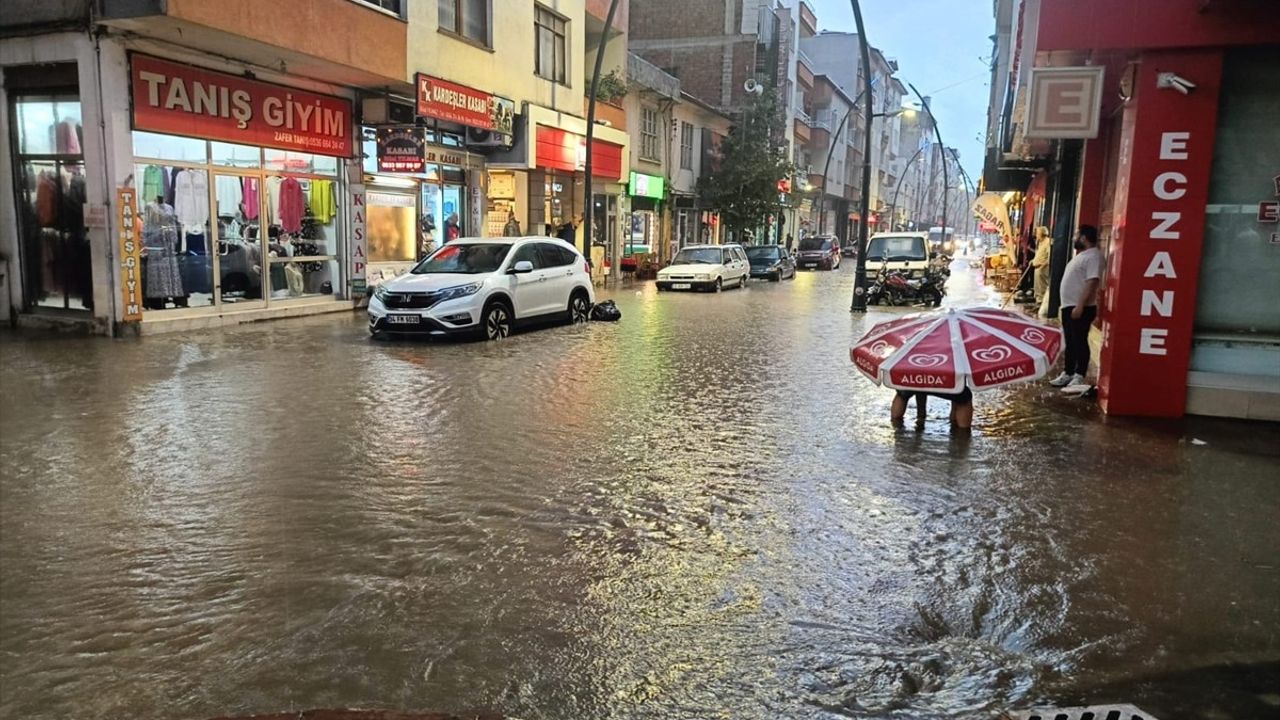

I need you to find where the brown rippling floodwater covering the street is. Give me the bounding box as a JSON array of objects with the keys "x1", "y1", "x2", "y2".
[{"x1": 0, "y1": 264, "x2": 1280, "y2": 720}]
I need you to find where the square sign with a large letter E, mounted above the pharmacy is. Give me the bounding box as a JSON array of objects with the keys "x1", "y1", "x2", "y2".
[{"x1": 1023, "y1": 65, "x2": 1103, "y2": 140}]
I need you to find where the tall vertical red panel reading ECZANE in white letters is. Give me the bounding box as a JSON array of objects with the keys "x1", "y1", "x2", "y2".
[{"x1": 1098, "y1": 49, "x2": 1222, "y2": 418}]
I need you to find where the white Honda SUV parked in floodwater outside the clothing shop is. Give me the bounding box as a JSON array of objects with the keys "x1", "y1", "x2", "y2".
[{"x1": 369, "y1": 237, "x2": 595, "y2": 340}]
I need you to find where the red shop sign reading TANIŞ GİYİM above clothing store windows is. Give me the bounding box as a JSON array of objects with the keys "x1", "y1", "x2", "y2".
[{"x1": 131, "y1": 55, "x2": 352, "y2": 158}]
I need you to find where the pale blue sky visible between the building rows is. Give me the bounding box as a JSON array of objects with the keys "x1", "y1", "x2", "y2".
[{"x1": 808, "y1": 0, "x2": 996, "y2": 182}]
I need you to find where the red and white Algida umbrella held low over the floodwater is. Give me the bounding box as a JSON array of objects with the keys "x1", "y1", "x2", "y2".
[{"x1": 849, "y1": 307, "x2": 1062, "y2": 393}]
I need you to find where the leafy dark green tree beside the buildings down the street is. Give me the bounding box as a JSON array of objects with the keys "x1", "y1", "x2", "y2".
[{"x1": 698, "y1": 92, "x2": 795, "y2": 238}]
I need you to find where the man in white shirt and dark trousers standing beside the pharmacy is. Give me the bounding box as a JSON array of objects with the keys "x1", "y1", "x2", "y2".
[{"x1": 1050, "y1": 225, "x2": 1103, "y2": 387}]
